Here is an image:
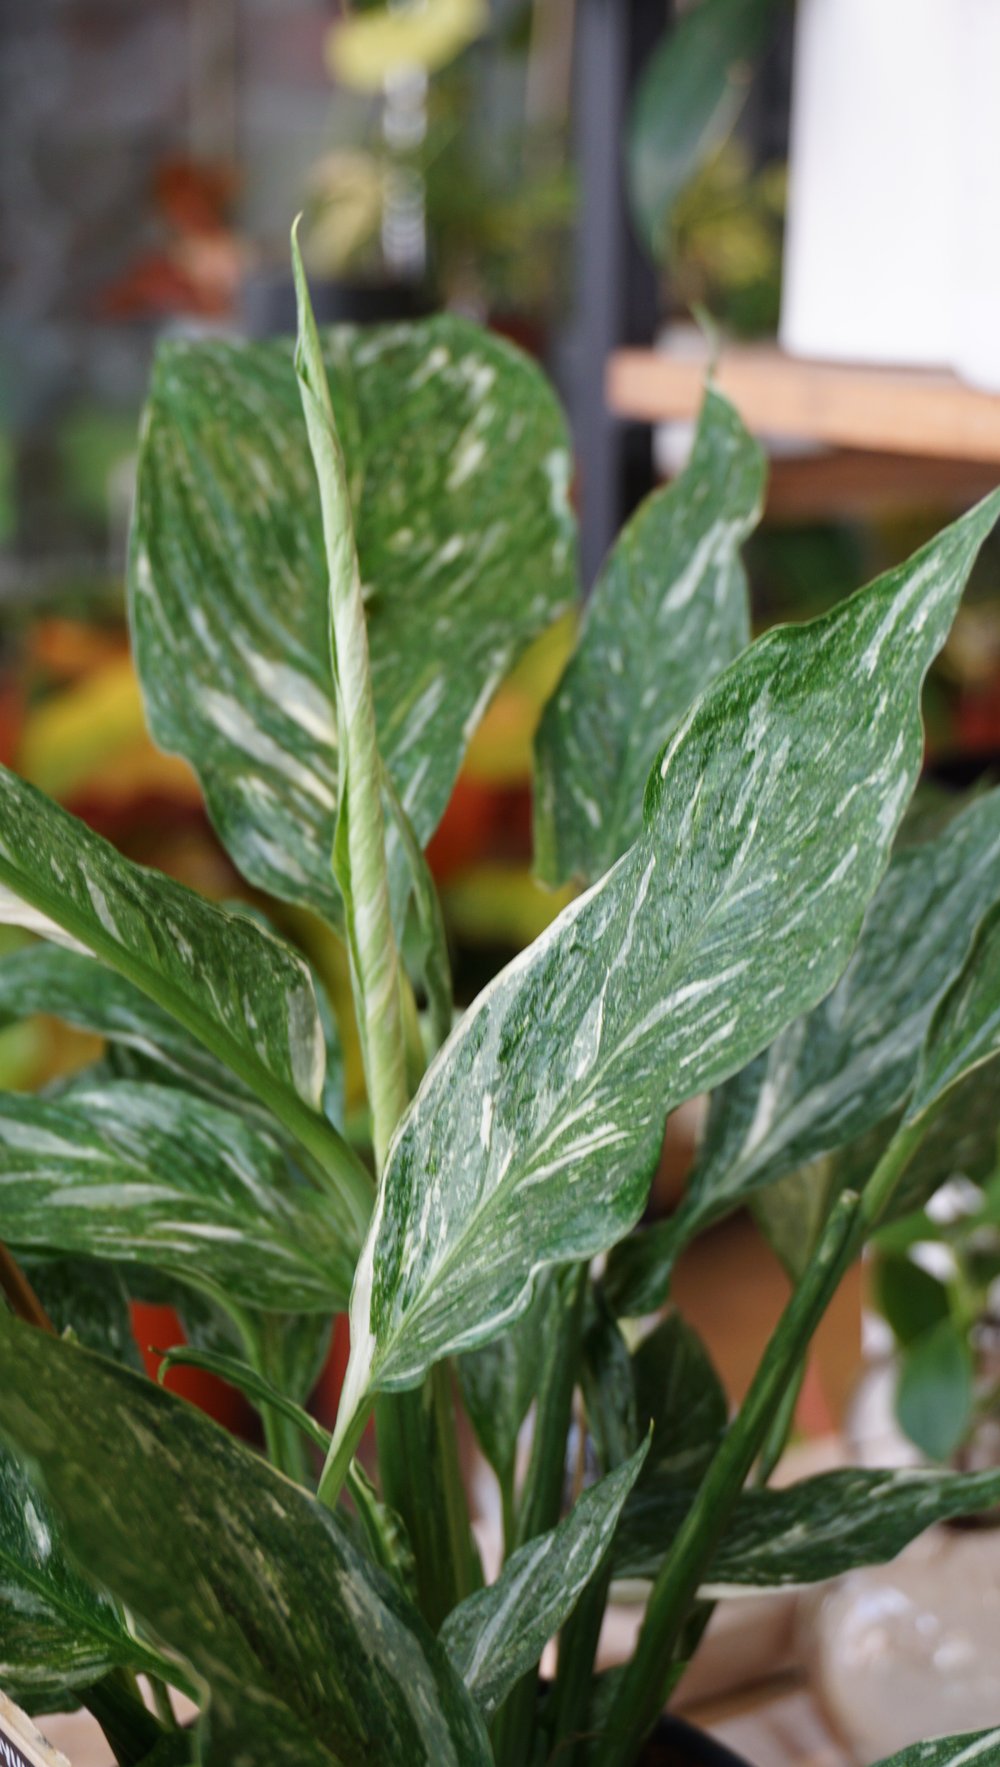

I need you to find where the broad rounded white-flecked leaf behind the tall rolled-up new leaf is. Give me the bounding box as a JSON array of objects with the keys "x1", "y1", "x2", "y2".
[{"x1": 129, "y1": 316, "x2": 576, "y2": 924}]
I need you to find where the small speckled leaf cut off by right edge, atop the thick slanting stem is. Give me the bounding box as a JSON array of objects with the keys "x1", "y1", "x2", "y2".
[{"x1": 905, "y1": 903, "x2": 1000, "y2": 1122}]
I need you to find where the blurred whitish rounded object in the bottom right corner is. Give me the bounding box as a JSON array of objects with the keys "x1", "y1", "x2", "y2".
[{"x1": 807, "y1": 1528, "x2": 1000, "y2": 1767}]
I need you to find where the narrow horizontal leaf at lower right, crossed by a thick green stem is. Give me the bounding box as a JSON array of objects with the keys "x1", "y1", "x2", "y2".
[{"x1": 615, "y1": 1467, "x2": 1000, "y2": 1596}]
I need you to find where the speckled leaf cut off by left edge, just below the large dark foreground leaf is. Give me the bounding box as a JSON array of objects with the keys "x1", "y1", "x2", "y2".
[{"x1": 0, "y1": 1449, "x2": 171, "y2": 1712}]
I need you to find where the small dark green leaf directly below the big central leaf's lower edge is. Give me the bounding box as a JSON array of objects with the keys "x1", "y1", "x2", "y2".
[{"x1": 458, "y1": 1272, "x2": 555, "y2": 1486}]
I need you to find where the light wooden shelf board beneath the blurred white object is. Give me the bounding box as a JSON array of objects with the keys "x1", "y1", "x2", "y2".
[{"x1": 608, "y1": 345, "x2": 1000, "y2": 466}]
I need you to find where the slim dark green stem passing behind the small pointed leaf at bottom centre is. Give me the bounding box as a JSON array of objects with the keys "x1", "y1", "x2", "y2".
[{"x1": 491, "y1": 1263, "x2": 587, "y2": 1767}]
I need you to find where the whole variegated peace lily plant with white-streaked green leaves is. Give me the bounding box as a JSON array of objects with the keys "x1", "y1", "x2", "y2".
[{"x1": 0, "y1": 231, "x2": 1000, "y2": 1767}]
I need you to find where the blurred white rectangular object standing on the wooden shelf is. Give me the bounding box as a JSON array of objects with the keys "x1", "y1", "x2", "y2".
[{"x1": 781, "y1": 0, "x2": 961, "y2": 366}]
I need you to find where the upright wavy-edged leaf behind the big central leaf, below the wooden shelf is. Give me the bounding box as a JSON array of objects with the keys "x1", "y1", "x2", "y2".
[{"x1": 535, "y1": 387, "x2": 765, "y2": 884}]
